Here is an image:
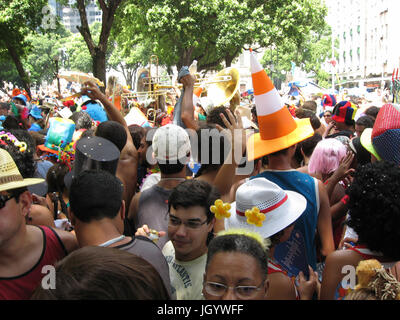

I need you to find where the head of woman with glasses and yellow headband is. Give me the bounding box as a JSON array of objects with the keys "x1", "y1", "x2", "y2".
[{"x1": 203, "y1": 229, "x2": 268, "y2": 300}]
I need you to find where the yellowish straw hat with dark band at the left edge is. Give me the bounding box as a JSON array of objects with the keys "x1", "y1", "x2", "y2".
[{"x1": 0, "y1": 148, "x2": 44, "y2": 191}]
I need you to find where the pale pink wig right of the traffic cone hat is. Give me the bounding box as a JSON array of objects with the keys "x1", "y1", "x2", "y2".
[{"x1": 308, "y1": 138, "x2": 347, "y2": 174}]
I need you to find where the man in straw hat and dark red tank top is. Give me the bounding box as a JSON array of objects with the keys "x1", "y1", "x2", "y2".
[{"x1": 0, "y1": 148, "x2": 77, "y2": 300}]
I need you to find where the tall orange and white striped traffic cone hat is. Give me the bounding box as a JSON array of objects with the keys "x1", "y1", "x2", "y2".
[{"x1": 247, "y1": 50, "x2": 314, "y2": 161}]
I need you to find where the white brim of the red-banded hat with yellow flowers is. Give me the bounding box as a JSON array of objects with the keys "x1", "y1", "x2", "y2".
[{"x1": 225, "y1": 190, "x2": 307, "y2": 238}]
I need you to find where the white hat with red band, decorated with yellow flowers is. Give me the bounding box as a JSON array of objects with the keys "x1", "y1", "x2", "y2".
[{"x1": 225, "y1": 178, "x2": 307, "y2": 238}]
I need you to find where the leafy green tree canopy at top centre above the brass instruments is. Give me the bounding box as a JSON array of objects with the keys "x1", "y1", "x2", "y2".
[{"x1": 117, "y1": 0, "x2": 326, "y2": 70}]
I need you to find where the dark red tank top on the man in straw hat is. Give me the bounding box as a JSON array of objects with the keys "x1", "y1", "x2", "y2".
[{"x1": 0, "y1": 226, "x2": 67, "y2": 300}]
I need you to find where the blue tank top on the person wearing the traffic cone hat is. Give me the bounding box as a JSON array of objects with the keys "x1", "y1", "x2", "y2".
[{"x1": 251, "y1": 170, "x2": 319, "y2": 270}]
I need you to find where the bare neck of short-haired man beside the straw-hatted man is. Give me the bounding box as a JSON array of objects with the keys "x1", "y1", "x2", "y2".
[{"x1": 75, "y1": 219, "x2": 131, "y2": 248}]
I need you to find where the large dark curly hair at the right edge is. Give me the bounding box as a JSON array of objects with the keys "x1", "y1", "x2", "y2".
[{"x1": 346, "y1": 161, "x2": 400, "y2": 261}]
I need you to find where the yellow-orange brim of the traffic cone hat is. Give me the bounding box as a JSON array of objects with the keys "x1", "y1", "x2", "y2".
[{"x1": 247, "y1": 118, "x2": 314, "y2": 161}]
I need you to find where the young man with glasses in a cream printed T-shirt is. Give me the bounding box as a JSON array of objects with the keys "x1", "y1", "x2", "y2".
[{"x1": 163, "y1": 180, "x2": 219, "y2": 300}]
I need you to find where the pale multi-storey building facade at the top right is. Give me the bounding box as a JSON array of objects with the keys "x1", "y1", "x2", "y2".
[{"x1": 325, "y1": 0, "x2": 400, "y2": 87}]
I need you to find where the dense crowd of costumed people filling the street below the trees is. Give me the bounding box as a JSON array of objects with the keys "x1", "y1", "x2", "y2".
[{"x1": 0, "y1": 50, "x2": 400, "y2": 300}]
